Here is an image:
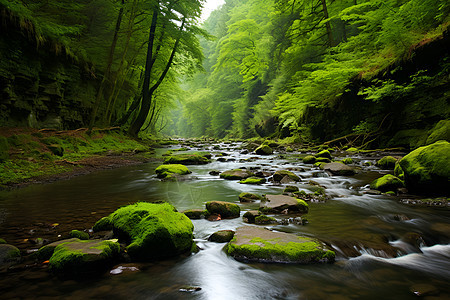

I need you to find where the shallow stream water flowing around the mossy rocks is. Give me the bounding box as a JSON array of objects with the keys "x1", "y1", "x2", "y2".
[{"x1": 0, "y1": 144, "x2": 450, "y2": 299}]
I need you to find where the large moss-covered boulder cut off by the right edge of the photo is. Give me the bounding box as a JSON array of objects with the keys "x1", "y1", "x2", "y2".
[{"x1": 399, "y1": 141, "x2": 450, "y2": 195}]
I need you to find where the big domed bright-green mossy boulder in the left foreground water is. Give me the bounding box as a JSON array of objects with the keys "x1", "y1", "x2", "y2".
[{"x1": 94, "y1": 202, "x2": 194, "y2": 260}]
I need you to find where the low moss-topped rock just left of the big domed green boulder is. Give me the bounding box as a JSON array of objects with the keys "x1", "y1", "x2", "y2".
[{"x1": 49, "y1": 239, "x2": 120, "y2": 276}]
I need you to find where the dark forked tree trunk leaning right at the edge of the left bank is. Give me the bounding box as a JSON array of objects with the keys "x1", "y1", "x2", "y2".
[{"x1": 128, "y1": 18, "x2": 186, "y2": 137}]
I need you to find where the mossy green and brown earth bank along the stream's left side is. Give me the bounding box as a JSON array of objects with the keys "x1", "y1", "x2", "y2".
[{"x1": 0, "y1": 127, "x2": 165, "y2": 189}]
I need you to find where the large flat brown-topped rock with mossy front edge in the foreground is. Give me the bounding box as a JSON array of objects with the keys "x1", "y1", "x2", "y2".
[{"x1": 225, "y1": 226, "x2": 335, "y2": 264}]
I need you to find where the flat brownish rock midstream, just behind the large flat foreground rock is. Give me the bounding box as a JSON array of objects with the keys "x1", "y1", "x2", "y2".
[{"x1": 259, "y1": 195, "x2": 308, "y2": 213}]
